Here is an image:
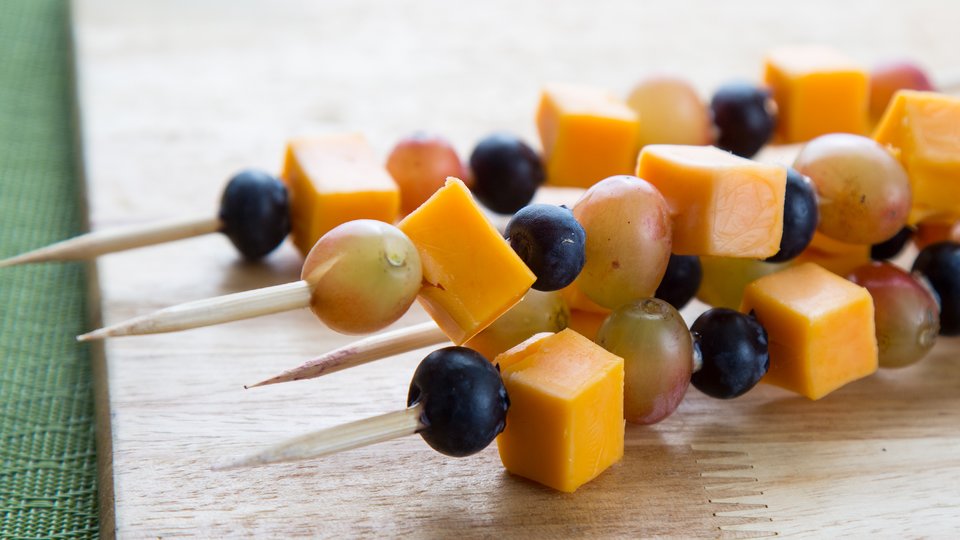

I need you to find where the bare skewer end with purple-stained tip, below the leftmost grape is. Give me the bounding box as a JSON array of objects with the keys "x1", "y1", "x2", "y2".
[{"x1": 244, "y1": 321, "x2": 449, "y2": 389}]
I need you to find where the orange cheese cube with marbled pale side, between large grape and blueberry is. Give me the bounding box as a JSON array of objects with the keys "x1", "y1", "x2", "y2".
[{"x1": 637, "y1": 144, "x2": 787, "y2": 259}]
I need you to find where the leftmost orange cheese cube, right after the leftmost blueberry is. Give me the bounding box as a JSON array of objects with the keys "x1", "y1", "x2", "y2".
[{"x1": 280, "y1": 134, "x2": 400, "y2": 255}]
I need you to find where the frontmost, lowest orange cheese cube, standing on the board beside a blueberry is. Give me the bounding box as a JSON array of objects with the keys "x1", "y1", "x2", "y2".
[{"x1": 497, "y1": 329, "x2": 624, "y2": 493}]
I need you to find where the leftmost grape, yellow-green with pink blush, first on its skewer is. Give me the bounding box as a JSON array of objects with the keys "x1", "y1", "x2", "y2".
[{"x1": 301, "y1": 219, "x2": 423, "y2": 334}]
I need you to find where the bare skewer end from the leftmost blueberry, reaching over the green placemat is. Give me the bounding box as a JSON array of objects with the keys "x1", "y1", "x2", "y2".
[{"x1": 0, "y1": 217, "x2": 223, "y2": 268}]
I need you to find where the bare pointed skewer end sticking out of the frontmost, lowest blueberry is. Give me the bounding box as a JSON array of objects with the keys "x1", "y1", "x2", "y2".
[{"x1": 223, "y1": 403, "x2": 425, "y2": 470}]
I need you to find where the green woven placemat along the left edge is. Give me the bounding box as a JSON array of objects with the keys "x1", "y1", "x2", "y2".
[{"x1": 0, "y1": 0, "x2": 97, "y2": 538}]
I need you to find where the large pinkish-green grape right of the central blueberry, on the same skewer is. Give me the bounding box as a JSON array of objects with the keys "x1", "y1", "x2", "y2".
[{"x1": 573, "y1": 175, "x2": 673, "y2": 309}]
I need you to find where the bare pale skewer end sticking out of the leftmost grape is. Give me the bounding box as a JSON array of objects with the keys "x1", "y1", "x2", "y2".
[{"x1": 77, "y1": 281, "x2": 311, "y2": 341}]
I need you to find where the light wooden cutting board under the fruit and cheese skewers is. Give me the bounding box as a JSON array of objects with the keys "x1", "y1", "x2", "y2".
[{"x1": 75, "y1": 0, "x2": 960, "y2": 538}]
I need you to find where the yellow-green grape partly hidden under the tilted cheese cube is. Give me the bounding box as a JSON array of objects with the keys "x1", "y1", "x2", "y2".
[{"x1": 464, "y1": 289, "x2": 570, "y2": 362}]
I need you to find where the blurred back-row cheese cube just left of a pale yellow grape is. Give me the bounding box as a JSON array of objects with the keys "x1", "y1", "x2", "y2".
[{"x1": 537, "y1": 85, "x2": 638, "y2": 188}]
